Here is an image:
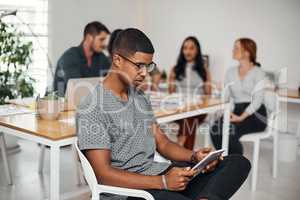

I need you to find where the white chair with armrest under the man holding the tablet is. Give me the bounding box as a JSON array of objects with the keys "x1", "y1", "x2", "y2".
[{"x1": 75, "y1": 139, "x2": 154, "y2": 200}]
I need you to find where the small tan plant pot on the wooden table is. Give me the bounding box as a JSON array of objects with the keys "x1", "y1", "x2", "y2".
[{"x1": 37, "y1": 99, "x2": 63, "y2": 120}]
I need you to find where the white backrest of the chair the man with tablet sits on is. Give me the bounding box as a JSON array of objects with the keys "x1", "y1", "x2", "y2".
[{"x1": 75, "y1": 139, "x2": 98, "y2": 190}]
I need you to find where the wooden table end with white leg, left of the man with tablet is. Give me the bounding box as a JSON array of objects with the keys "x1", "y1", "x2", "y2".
[{"x1": 0, "y1": 112, "x2": 76, "y2": 200}]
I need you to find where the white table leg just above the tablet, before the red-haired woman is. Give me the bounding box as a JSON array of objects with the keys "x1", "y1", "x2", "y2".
[{"x1": 222, "y1": 104, "x2": 230, "y2": 156}]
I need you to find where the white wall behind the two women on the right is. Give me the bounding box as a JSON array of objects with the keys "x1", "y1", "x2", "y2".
[{"x1": 144, "y1": 0, "x2": 300, "y2": 87}]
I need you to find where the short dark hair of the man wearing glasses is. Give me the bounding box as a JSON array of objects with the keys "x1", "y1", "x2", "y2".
[{"x1": 112, "y1": 28, "x2": 154, "y2": 56}]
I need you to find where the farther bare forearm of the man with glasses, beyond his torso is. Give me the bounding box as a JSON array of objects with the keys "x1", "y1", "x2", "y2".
[{"x1": 152, "y1": 123, "x2": 193, "y2": 162}]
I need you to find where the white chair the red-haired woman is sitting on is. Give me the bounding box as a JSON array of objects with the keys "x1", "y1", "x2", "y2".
[{"x1": 240, "y1": 92, "x2": 279, "y2": 191}]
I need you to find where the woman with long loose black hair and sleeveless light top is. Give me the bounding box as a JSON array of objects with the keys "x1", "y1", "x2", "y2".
[{"x1": 169, "y1": 36, "x2": 211, "y2": 150}]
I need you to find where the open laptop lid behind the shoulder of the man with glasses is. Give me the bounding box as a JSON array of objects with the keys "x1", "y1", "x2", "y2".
[{"x1": 65, "y1": 77, "x2": 103, "y2": 110}]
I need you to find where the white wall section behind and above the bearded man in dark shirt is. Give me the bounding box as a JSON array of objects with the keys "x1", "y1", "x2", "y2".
[{"x1": 49, "y1": 0, "x2": 141, "y2": 65}]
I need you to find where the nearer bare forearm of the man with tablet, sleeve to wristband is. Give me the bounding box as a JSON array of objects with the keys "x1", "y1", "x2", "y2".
[{"x1": 85, "y1": 149, "x2": 163, "y2": 189}]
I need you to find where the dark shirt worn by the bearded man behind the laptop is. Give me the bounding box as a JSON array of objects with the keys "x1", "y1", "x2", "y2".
[{"x1": 53, "y1": 45, "x2": 111, "y2": 96}]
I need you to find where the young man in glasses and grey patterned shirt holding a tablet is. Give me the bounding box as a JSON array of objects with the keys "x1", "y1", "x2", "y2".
[{"x1": 76, "y1": 29, "x2": 250, "y2": 200}]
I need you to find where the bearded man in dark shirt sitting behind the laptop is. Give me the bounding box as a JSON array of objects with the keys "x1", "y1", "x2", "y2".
[{"x1": 53, "y1": 21, "x2": 110, "y2": 97}]
